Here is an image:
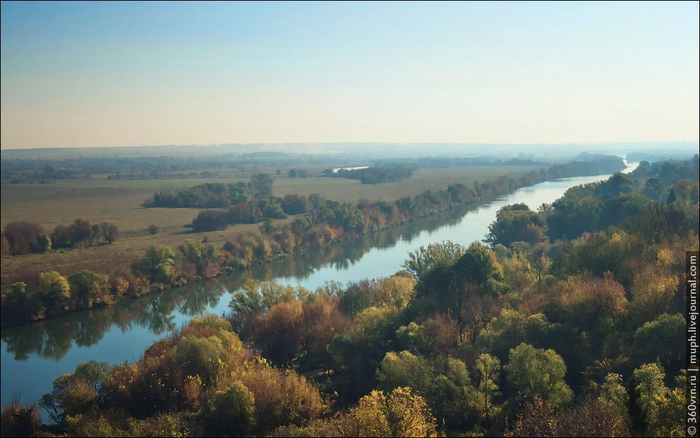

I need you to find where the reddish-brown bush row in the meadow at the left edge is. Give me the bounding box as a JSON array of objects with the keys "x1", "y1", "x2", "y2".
[{"x1": 2, "y1": 219, "x2": 119, "y2": 256}]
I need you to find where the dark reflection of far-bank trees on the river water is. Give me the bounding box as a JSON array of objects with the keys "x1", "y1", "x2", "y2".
[{"x1": 2, "y1": 204, "x2": 474, "y2": 361}]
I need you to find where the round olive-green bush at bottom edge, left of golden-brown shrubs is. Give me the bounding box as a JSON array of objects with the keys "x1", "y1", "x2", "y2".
[{"x1": 203, "y1": 382, "x2": 255, "y2": 436}]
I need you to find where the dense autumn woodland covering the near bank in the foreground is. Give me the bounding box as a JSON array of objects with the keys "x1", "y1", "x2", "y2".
[{"x1": 1, "y1": 156, "x2": 698, "y2": 436}]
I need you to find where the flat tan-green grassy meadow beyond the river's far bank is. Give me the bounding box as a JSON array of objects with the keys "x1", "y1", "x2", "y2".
[{"x1": 0, "y1": 163, "x2": 544, "y2": 289}]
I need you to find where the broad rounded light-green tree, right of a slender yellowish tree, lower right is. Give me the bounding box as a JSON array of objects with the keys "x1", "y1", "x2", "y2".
[{"x1": 504, "y1": 343, "x2": 573, "y2": 406}]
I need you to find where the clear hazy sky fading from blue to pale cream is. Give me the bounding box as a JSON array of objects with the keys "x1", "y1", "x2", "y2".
[{"x1": 0, "y1": 2, "x2": 700, "y2": 149}]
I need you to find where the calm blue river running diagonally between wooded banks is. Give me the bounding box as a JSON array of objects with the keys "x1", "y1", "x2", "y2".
[{"x1": 0, "y1": 163, "x2": 638, "y2": 414}]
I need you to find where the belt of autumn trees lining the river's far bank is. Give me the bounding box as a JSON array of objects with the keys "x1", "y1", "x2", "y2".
[{"x1": 2, "y1": 157, "x2": 632, "y2": 324}]
